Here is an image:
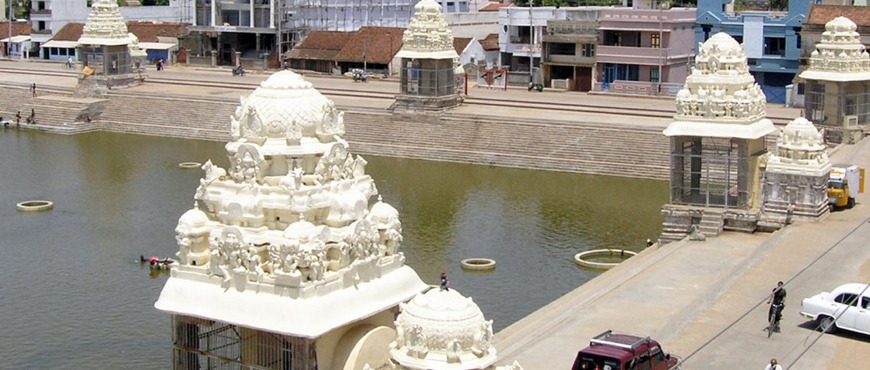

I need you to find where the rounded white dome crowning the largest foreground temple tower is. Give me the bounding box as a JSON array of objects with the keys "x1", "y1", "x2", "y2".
[{"x1": 233, "y1": 70, "x2": 344, "y2": 139}]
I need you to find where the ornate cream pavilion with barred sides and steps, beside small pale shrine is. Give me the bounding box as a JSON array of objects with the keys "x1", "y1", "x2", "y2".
[{"x1": 661, "y1": 33, "x2": 776, "y2": 242}]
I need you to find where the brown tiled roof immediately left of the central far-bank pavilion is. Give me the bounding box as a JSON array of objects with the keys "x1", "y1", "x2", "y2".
[{"x1": 335, "y1": 27, "x2": 405, "y2": 64}]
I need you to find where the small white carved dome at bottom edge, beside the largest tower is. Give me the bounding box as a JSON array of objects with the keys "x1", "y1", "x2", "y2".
[{"x1": 390, "y1": 288, "x2": 496, "y2": 369}]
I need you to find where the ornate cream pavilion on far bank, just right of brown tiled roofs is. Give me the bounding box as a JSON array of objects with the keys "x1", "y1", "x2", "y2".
[{"x1": 392, "y1": 0, "x2": 462, "y2": 112}]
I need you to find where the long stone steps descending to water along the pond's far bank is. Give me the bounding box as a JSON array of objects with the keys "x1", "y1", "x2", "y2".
[{"x1": 0, "y1": 87, "x2": 784, "y2": 180}]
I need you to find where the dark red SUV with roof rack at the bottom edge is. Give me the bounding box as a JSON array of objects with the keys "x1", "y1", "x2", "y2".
[{"x1": 571, "y1": 330, "x2": 681, "y2": 370}]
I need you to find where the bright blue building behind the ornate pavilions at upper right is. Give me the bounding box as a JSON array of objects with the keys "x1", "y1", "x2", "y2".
[{"x1": 695, "y1": 0, "x2": 810, "y2": 103}]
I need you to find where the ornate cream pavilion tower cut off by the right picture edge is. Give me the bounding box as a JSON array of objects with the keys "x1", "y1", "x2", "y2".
[{"x1": 800, "y1": 17, "x2": 870, "y2": 144}]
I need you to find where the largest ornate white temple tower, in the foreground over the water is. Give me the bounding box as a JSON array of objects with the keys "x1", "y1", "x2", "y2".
[{"x1": 155, "y1": 71, "x2": 427, "y2": 370}]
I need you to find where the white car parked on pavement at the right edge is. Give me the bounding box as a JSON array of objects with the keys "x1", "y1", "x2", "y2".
[{"x1": 801, "y1": 283, "x2": 870, "y2": 334}]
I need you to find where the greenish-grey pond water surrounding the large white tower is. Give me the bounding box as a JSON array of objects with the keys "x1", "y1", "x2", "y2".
[{"x1": 0, "y1": 128, "x2": 668, "y2": 369}]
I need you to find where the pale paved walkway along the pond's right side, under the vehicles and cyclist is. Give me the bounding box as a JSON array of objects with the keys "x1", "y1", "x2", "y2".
[{"x1": 494, "y1": 140, "x2": 870, "y2": 369}]
